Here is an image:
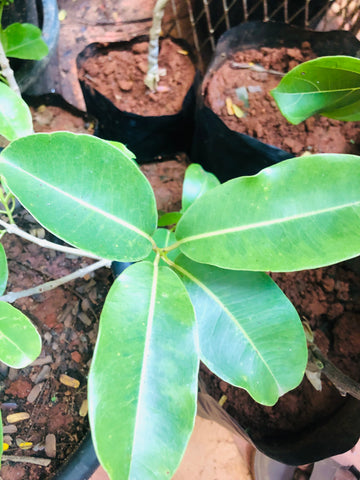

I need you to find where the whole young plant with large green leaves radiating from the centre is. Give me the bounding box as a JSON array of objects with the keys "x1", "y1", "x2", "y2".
[{"x1": 0, "y1": 75, "x2": 360, "y2": 480}]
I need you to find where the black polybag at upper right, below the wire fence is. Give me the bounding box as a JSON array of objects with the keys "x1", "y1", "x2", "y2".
[{"x1": 190, "y1": 22, "x2": 360, "y2": 182}]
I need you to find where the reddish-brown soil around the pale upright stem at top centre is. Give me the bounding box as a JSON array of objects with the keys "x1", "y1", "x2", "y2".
[{"x1": 79, "y1": 39, "x2": 195, "y2": 116}]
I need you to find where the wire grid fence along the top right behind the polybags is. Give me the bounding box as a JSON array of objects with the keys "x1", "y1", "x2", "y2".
[{"x1": 167, "y1": 0, "x2": 360, "y2": 67}]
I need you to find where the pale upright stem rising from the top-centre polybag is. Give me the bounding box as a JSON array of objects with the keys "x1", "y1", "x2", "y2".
[{"x1": 144, "y1": 0, "x2": 168, "y2": 92}]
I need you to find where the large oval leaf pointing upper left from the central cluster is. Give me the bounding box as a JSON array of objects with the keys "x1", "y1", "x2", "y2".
[{"x1": 0, "y1": 132, "x2": 157, "y2": 262}]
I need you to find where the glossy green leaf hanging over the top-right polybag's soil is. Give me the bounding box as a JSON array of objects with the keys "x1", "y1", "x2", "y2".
[{"x1": 271, "y1": 56, "x2": 360, "y2": 125}]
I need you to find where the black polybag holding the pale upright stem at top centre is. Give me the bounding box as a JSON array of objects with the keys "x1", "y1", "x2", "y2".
[{"x1": 77, "y1": 36, "x2": 198, "y2": 164}]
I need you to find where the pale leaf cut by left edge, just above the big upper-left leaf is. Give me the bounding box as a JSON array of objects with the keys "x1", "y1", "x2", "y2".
[{"x1": 0, "y1": 82, "x2": 33, "y2": 141}]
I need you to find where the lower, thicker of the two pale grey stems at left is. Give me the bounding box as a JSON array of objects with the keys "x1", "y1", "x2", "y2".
[{"x1": 0, "y1": 260, "x2": 111, "y2": 303}]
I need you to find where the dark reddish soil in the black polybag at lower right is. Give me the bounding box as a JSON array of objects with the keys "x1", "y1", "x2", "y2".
[{"x1": 201, "y1": 262, "x2": 360, "y2": 439}]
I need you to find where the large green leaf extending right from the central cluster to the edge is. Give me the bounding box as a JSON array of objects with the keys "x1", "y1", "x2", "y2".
[{"x1": 175, "y1": 154, "x2": 360, "y2": 272}]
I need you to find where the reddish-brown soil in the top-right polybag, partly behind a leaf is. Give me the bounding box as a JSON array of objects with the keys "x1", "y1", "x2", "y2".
[{"x1": 204, "y1": 42, "x2": 360, "y2": 156}]
